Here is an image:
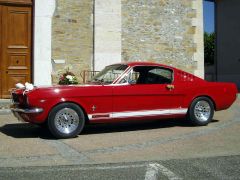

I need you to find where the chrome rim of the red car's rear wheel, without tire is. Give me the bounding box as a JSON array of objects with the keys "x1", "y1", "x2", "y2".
[{"x1": 194, "y1": 101, "x2": 211, "y2": 122}]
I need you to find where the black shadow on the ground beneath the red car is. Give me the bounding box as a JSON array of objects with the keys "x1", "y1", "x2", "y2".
[{"x1": 0, "y1": 119, "x2": 219, "y2": 140}]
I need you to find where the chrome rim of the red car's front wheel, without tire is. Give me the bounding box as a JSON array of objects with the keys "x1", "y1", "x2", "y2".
[{"x1": 54, "y1": 108, "x2": 79, "y2": 134}]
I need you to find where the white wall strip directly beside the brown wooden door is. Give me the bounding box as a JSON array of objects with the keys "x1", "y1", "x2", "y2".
[{"x1": 34, "y1": 0, "x2": 55, "y2": 85}]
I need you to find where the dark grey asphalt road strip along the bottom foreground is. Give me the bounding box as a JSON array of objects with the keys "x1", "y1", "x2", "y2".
[{"x1": 0, "y1": 156, "x2": 240, "y2": 180}]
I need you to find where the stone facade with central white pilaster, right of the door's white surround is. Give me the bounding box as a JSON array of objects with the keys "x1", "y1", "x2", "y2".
[{"x1": 51, "y1": 0, "x2": 204, "y2": 83}]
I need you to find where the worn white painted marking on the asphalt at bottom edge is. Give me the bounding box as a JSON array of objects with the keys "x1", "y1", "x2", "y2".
[{"x1": 145, "y1": 163, "x2": 182, "y2": 180}]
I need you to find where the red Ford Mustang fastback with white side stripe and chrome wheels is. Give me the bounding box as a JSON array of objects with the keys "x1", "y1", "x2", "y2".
[{"x1": 11, "y1": 62, "x2": 237, "y2": 138}]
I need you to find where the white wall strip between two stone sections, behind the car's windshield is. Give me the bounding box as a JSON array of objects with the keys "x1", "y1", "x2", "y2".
[{"x1": 94, "y1": 0, "x2": 122, "y2": 70}]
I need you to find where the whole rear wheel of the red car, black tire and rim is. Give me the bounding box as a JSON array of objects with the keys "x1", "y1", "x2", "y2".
[{"x1": 188, "y1": 97, "x2": 214, "y2": 126}]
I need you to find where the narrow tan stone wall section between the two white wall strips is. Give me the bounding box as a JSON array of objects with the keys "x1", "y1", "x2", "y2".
[{"x1": 52, "y1": 0, "x2": 93, "y2": 84}]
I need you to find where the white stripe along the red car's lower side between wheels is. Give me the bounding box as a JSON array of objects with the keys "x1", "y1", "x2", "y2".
[{"x1": 88, "y1": 108, "x2": 187, "y2": 119}]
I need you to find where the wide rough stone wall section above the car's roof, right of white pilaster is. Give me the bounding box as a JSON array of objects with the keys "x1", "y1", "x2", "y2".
[{"x1": 122, "y1": 0, "x2": 203, "y2": 73}]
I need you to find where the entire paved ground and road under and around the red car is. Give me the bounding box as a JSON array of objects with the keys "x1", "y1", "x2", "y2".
[{"x1": 0, "y1": 95, "x2": 240, "y2": 179}]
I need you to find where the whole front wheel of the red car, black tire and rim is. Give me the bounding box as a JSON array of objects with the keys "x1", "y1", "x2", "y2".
[{"x1": 48, "y1": 103, "x2": 85, "y2": 139}]
